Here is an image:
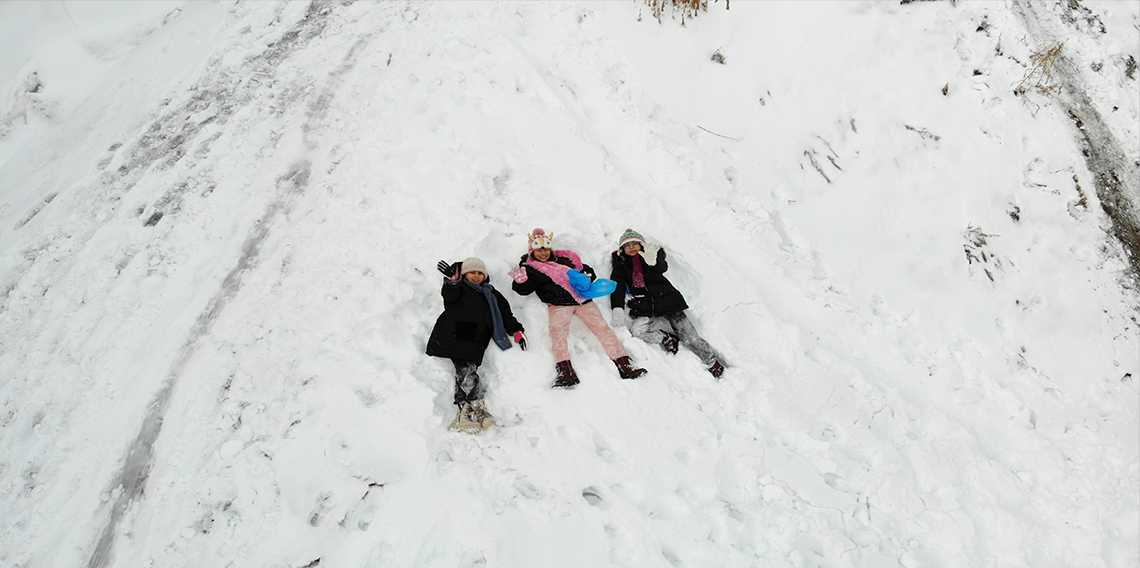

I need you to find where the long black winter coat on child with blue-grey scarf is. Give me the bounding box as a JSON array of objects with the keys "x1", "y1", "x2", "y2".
[{"x1": 428, "y1": 271, "x2": 522, "y2": 365}]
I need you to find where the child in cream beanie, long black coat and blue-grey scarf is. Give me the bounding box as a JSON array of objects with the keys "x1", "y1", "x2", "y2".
[{"x1": 428, "y1": 258, "x2": 527, "y2": 433}]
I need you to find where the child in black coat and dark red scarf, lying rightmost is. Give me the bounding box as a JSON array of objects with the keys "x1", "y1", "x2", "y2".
[{"x1": 610, "y1": 229, "x2": 724, "y2": 379}]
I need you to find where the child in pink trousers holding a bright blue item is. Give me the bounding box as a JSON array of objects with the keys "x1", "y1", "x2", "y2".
[{"x1": 510, "y1": 229, "x2": 645, "y2": 388}]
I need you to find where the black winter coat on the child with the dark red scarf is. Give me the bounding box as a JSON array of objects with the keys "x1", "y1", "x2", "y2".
[{"x1": 610, "y1": 249, "x2": 689, "y2": 317}]
